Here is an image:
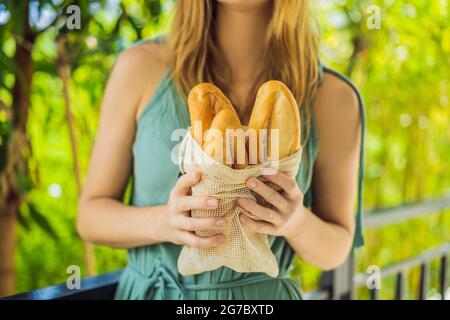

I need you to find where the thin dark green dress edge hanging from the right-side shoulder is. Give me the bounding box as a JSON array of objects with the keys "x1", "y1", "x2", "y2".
[{"x1": 320, "y1": 63, "x2": 366, "y2": 248}]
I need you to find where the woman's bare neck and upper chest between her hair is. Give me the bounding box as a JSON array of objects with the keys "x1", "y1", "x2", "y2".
[{"x1": 216, "y1": 1, "x2": 272, "y2": 87}]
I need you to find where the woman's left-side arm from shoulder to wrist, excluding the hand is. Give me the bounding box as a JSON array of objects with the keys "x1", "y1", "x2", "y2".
[{"x1": 77, "y1": 48, "x2": 164, "y2": 247}]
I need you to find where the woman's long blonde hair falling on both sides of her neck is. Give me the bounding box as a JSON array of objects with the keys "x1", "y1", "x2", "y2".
[{"x1": 169, "y1": 0, "x2": 319, "y2": 141}]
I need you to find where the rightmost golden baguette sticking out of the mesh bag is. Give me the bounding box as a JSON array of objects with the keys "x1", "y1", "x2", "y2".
[{"x1": 248, "y1": 80, "x2": 301, "y2": 164}]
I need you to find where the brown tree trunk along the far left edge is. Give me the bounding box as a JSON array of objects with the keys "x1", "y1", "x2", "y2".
[{"x1": 0, "y1": 2, "x2": 36, "y2": 296}]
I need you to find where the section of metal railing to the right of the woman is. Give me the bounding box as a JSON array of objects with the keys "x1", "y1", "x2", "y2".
[{"x1": 305, "y1": 194, "x2": 450, "y2": 300}]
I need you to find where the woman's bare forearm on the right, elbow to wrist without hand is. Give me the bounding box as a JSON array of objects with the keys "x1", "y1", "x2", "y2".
[{"x1": 287, "y1": 208, "x2": 352, "y2": 270}]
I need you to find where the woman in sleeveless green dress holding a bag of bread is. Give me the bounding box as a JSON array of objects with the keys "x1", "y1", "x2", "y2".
[{"x1": 78, "y1": 0, "x2": 364, "y2": 299}]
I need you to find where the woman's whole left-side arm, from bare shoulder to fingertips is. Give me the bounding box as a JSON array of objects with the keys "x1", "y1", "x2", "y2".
[{"x1": 77, "y1": 47, "x2": 227, "y2": 248}]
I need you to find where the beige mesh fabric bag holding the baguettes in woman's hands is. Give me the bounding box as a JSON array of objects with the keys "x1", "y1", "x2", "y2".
[{"x1": 178, "y1": 131, "x2": 302, "y2": 277}]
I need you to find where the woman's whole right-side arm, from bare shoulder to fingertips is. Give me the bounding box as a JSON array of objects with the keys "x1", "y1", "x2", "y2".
[{"x1": 241, "y1": 74, "x2": 361, "y2": 270}]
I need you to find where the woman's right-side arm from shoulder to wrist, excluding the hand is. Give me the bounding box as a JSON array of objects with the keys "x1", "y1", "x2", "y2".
[{"x1": 292, "y1": 73, "x2": 361, "y2": 269}]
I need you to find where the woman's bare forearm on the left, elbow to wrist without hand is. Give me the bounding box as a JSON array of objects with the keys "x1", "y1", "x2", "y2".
[{"x1": 77, "y1": 198, "x2": 165, "y2": 248}]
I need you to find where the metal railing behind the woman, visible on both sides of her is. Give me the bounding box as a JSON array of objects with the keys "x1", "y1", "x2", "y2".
[{"x1": 4, "y1": 195, "x2": 450, "y2": 300}]
